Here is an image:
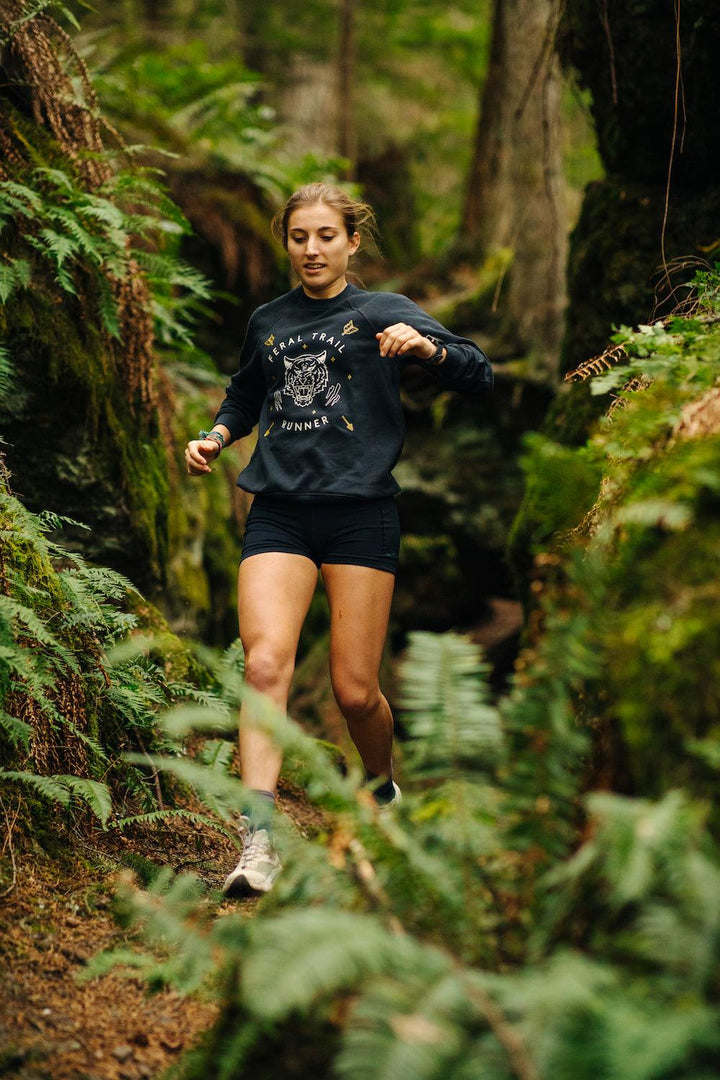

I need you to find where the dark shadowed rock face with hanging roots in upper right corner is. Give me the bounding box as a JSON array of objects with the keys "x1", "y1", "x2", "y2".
[{"x1": 560, "y1": 0, "x2": 720, "y2": 370}]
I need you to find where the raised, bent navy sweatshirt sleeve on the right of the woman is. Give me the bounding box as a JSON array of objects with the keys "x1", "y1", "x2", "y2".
[{"x1": 362, "y1": 293, "x2": 493, "y2": 393}]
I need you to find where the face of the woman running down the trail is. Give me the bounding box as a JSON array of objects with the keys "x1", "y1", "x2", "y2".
[{"x1": 287, "y1": 203, "x2": 361, "y2": 300}]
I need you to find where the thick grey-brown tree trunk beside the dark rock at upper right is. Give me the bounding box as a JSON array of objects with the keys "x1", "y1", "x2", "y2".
[{"x1": 457, "y1": 0, "x2": 567, "y2": 377}]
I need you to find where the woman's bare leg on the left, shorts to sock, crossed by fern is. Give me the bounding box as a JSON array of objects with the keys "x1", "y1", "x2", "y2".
[{"x1": 237, "y1": 552, "x2": 317, "y2": 792}]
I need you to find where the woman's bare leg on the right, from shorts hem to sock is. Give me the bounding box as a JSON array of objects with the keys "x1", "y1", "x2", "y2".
[{"x1": 322, "y1": 563, "x2": 395, "y2": 777}]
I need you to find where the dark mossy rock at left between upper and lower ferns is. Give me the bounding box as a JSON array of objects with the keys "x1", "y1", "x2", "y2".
[{"x1": 0, "y1": 267, "x2": 168, "y2": 588}]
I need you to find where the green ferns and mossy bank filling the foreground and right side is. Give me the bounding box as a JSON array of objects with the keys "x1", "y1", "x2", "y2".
[{"x1": 83, "y1": 265, "x2": 720, "y2": 1080}]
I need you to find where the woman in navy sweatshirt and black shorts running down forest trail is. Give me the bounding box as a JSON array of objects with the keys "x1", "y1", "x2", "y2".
[{"x1": 185, "y1": 184, "x2": 492, "y2": 895}]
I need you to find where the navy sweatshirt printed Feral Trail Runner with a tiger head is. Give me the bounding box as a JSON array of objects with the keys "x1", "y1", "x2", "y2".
[{"x1": 215, "y1": 285, "x2": 492, "y2": 499}]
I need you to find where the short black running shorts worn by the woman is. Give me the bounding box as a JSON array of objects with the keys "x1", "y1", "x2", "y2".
[{"x1": 241, "y1": 495, "x2": 400, "y2": 573}]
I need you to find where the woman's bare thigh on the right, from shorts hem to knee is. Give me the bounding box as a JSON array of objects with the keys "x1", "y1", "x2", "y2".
[{"x1": 322, "y1": 564, "x2": 395, "y2": 687}]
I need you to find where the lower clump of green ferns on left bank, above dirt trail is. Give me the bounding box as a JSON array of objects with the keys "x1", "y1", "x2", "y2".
[{"x1": 0, "y1": 475, "x2": 218, "y2": 827}]
